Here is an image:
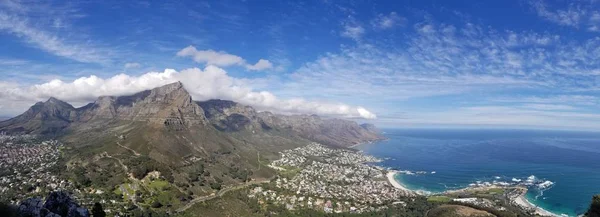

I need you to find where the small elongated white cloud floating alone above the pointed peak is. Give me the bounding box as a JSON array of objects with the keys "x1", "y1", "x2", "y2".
[{"x1": 177, "y1": 45, "x2": 273, "y2": 71}]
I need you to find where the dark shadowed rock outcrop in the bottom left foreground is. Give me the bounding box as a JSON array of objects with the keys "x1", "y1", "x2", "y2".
[{"x1": 19, "y1": 192, "x2": 90, "y2": 217}]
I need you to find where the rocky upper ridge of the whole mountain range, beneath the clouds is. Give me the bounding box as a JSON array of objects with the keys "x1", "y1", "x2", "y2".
[{"x1": 0, "y1": 82, "x2": 382, "y2": 147}]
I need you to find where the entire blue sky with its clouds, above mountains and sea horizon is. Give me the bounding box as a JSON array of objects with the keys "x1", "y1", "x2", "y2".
[{"x1": 0, "y1": 0, "x2": 600, "y2": 130}]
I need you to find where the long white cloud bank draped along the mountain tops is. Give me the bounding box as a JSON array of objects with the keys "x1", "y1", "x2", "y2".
[{"x1": 0, "y1": 65, "x2": 376, "y2": 119}]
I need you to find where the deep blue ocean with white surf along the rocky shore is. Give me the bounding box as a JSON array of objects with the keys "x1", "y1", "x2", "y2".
[{"x1": 356, "y1": 129, "x2": 600, "y2": 216}]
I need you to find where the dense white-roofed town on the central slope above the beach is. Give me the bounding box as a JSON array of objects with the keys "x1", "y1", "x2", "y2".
[{"x1": 255, "y1": 143, "x2": 413, "y2": 213}]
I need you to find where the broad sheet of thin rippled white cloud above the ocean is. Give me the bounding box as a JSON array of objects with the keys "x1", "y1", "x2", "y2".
[{"x1": 288, "y1": 20, "x2": 600, "y2": 107}]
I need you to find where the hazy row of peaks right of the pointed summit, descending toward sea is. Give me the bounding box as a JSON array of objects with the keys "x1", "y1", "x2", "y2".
[{"x1": 198, "y1": 100, "x2": 382, "y2": 147}]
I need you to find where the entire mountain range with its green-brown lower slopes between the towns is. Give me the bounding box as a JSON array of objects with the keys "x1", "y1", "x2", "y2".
[{"x1": 0, "y1": 82, "x2": 381, "y2": 215}]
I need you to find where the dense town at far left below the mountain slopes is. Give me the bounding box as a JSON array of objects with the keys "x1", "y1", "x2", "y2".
[{"x1": 0, "y1": 134, "x2": 130, "y2": 215}]
